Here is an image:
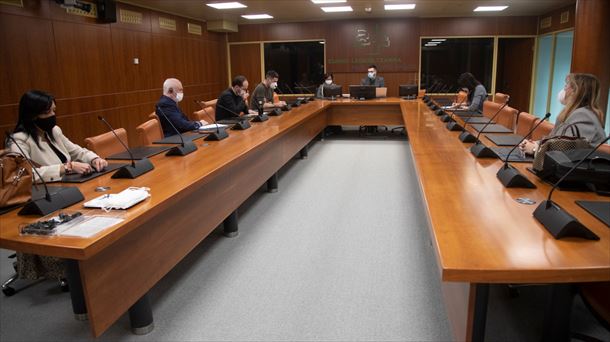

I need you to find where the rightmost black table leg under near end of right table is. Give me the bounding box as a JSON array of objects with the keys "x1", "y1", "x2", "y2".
[{"x1": 542, "y1": 284, "x2": 575, "y2": 342}]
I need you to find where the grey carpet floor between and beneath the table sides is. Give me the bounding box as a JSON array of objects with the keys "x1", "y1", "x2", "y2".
[{"x1": 0, "y1": 130, "x2": 604, "y2": 341}]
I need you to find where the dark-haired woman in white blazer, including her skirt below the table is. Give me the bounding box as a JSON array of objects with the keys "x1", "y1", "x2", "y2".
[{"x1": 7, "y1": 90, "x2": 108, "y2": 280}]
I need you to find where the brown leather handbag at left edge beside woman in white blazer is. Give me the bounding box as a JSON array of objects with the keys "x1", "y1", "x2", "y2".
[{"x1": 0, "y1": 150, "x2": 32, "y2": 208}]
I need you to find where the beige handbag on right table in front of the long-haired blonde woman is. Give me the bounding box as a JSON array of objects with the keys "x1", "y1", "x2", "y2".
[{"x1": 532, "y1": 122, "x2": 592, "y2": 174}]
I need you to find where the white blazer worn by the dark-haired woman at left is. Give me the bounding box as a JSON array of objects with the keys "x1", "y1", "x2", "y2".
[{"x1": 9, "y1": 126, "x2": 98, "y2": 183}]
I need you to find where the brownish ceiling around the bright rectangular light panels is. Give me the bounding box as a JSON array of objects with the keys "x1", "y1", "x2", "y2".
[{"x1": 118, "y1": 0, "x2": 576, "y2": 24}]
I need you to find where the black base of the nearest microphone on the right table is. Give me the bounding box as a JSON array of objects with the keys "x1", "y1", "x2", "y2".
[{"x1": 534, "y1": 200, "x2": 599, "y2": 240}]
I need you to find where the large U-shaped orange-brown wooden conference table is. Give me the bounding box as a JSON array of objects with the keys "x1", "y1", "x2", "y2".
[{"x1": 0, "y1": 98, "x2": 610, "y2": 341}]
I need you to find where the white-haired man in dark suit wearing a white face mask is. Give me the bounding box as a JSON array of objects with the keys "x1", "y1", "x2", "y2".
[{"x1": 155, "y1": 78, "x2": 208, "y2": 137}]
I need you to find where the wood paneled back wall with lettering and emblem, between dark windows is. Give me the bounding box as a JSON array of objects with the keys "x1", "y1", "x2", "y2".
[{"x1": 229, "y1": 17, "x2": 538, "y2": 96}]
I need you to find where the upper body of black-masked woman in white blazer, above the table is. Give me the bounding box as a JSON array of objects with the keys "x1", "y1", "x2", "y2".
[{"x1": 7, "y1": 90, "x2": 108, "y2": 182}]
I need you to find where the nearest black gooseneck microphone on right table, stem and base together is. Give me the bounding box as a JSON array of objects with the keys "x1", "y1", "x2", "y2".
[{"x1": 533, "y1": 135, "x2": 610, "y2": 240}]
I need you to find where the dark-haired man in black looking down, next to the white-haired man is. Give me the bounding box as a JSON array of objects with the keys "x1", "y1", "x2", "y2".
[{"x1": 216, "y1": 75, "x2": 256, "y2": 120}]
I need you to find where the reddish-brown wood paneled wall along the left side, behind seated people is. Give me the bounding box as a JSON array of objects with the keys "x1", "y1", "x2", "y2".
[{"x1": 0, "y1": 0, "x2": 227, "y2": 145}]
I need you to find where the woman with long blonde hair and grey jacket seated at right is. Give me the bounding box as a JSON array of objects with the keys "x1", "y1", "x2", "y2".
[{"x1": 519, "y1": 74, "x2": 605, "y2": 155}]
